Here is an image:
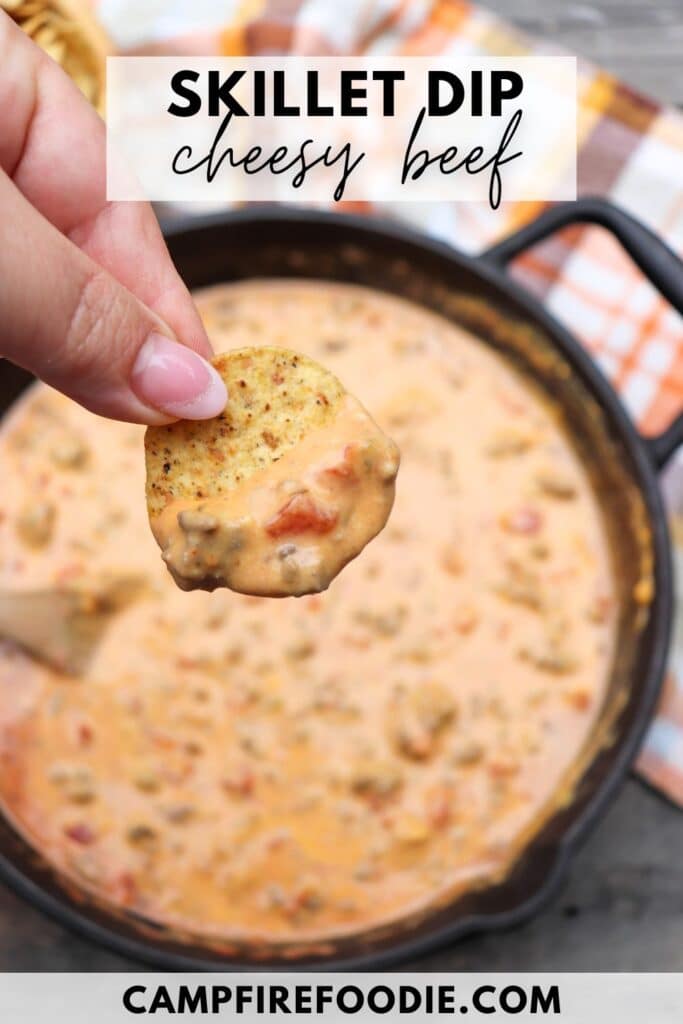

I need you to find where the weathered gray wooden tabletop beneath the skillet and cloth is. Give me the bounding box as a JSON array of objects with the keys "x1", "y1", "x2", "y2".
[{"x1": 0, "y1": 0, "x2": 683, "y2": 971}]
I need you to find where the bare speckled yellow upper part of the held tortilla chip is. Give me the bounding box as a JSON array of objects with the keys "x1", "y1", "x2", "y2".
[{"x1": 144, "y1": 347, "x2": 346, "y2": 519}]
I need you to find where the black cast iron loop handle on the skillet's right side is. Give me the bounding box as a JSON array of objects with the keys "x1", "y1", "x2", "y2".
[{"x1": 481, "y1": 196, "x2": 683, "y2": 468}]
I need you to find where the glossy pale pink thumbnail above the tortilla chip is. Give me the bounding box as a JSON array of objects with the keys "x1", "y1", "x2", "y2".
[{"x1": 130, "y1": 334, "x2": 227, "y2": 420}]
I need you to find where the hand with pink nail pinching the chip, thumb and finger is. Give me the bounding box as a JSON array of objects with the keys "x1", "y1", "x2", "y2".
[{"x1": 0, "y1": 12, "x2": 226, "y2": 423}]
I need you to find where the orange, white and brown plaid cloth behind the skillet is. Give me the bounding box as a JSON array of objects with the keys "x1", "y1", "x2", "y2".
[{"x1": 95, "y1": 0, "x2": 683, "y2": 805}]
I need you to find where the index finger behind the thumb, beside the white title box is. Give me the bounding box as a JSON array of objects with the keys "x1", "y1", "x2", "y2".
[{"x1": 0, "y1": 11, "x2": 212, "y2": 356}]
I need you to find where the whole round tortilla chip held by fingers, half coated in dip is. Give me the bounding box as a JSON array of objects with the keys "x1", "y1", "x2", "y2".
[{"x1": 144, "y1": 347, "x2": 399, "y2": 597}]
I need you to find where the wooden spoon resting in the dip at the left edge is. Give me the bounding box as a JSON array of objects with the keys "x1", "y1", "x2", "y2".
[{"x1": 0, "y1": 577, "x2": 143, "y2": 676}]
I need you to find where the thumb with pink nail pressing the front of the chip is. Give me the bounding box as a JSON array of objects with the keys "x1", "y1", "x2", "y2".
[{"x1": 0, "y1": 172, "x2": 227, "y2": 424}]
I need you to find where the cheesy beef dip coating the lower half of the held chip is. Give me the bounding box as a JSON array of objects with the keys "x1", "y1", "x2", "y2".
[{"x1": 152, "y1": 394, "x2": 399, "y2": 597}]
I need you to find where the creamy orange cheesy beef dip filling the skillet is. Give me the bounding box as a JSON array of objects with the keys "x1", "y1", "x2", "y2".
[{"x1": 0, "y1": 282, "x2": 616, "y2": 941}]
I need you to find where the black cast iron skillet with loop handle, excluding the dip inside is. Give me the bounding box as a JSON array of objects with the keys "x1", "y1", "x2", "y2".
[{"x1": 0, "y1": 193, "x2": 683, "y2": 970}]
